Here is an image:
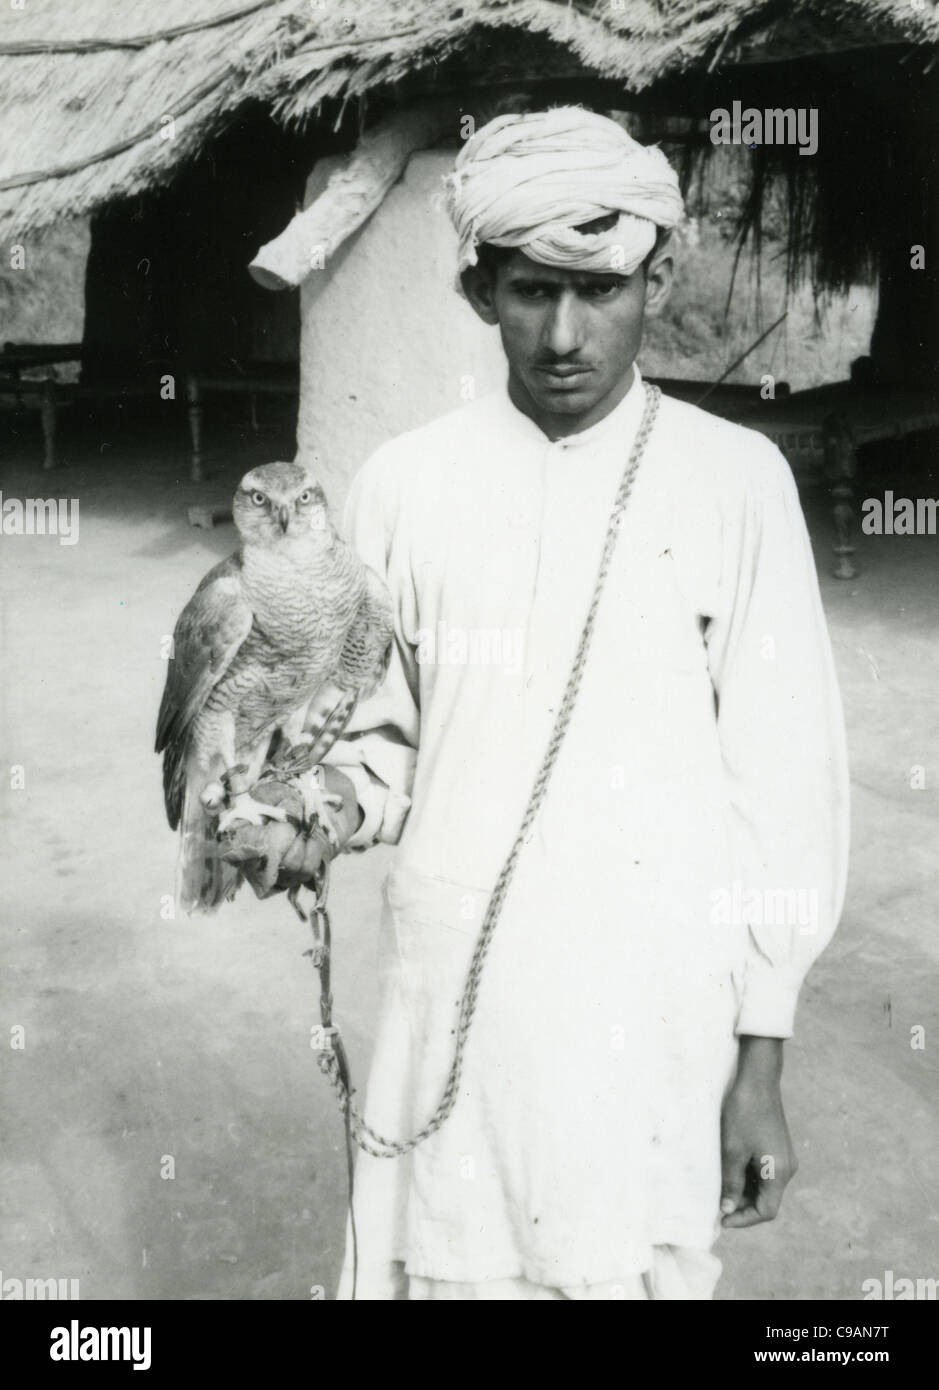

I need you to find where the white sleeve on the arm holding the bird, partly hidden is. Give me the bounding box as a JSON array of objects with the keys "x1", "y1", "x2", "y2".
[{"x1": 326, "y1": 449, "x2": 419, "y2": 849}]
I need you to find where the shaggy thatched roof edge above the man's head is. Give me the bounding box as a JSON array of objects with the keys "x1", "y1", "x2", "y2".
[{"x1": 0, "y1": 0, "x2": 939, "y2": 238}]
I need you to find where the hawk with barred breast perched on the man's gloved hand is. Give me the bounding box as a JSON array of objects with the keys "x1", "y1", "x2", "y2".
[{"x1": 156, "y1": 463, "x2": 393, "y2": 912}]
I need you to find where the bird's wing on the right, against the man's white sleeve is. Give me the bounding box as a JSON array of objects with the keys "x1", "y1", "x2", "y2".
[{"x1": 297, "y1": 564, "x2": 394, "y2": 766}]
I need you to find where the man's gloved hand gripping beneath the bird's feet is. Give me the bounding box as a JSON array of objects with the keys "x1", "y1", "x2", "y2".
[{"x1": 221, "y1": 765, "x2": 361, "y2": 898}]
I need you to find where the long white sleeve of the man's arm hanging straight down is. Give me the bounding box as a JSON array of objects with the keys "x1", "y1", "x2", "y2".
[{"x1": 706, "y1": 443, "x2": 849, "y2": 1037}]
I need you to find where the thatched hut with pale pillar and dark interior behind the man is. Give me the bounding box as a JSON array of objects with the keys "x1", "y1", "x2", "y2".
[{"x1": 0, "y1": 0, "x2": 939, "y2": 525}]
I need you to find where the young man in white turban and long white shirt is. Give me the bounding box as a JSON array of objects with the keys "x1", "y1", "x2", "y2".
[{"x1": 229, "y1": 108, "x2": 847, "y2": 1300}]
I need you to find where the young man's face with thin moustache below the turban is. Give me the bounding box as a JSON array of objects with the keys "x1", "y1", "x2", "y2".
[{"x1": 464, "y1": 252, "x2": 671, "y2": 436}]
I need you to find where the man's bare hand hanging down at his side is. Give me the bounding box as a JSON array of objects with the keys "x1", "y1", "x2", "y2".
[{"x1": 721, "y1": 1037, "x2": 799, "y2": 1227}]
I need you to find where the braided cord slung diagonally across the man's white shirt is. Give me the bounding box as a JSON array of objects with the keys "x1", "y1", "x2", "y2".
[{"x1": 319, "y1": 382, "x2": 661, "y2": 1158}]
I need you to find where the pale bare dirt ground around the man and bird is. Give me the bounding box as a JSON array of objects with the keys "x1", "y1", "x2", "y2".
[{"x1": 0, "y1": 405, "x2": 939, "y2": 1300}]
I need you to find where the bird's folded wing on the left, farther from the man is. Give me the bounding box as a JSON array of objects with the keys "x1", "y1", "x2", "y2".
[{"x1": 156, "y1": 556, "x2": 253, "y2": 824}]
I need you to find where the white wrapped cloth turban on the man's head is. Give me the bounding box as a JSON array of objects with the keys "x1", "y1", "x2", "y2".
[{"x1": 444, "y1": 106, "x2": 683, "y2": 275}]
